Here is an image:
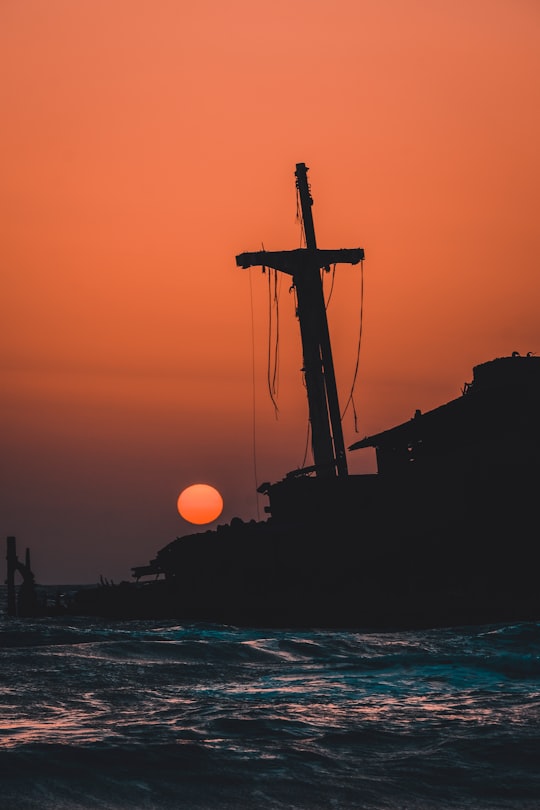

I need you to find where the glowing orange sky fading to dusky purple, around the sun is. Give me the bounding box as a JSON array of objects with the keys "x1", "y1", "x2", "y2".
[{"x1": 0, "y1": 0, "x2": 540, "y2": 583}]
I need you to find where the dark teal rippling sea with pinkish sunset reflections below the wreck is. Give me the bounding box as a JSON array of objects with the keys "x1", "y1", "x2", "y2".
[{"x1": 0, "y1": 591, "x2": 540, "y2": 810}]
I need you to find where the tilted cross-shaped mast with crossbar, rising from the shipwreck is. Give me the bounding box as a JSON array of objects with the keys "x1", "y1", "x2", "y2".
[{"x1": 236, "y1": 163, "x2": 364, "y2": 477}]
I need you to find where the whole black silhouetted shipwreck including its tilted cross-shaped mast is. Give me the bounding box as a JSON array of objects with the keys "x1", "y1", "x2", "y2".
[{"x1": 8, "y1": 163, "x2": 540, "y2": 630}]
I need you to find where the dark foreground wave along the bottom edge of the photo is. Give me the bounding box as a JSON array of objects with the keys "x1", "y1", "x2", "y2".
[{"x1": 0, "y1": 729, "x2": 540, "y2": 810}]
